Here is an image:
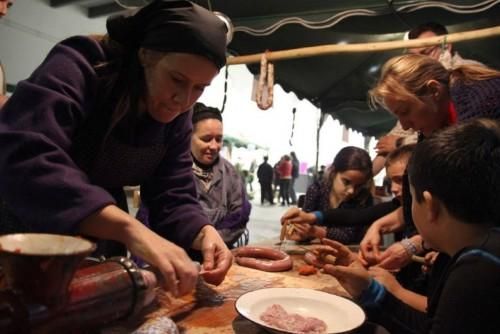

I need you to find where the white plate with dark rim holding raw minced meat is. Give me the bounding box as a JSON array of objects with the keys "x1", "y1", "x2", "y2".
[{"x1": 236, "y1": 288, "x2": 365, "y2": 334}]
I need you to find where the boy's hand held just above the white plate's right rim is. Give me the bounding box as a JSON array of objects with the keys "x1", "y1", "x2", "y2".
[{"x1": 323, "y1": 261, "x2": 370, "y2": 298}]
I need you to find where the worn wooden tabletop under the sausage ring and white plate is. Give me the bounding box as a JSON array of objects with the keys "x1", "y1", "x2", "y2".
[{"x1": 107, "y1": 243, "x2": 347, "y2": 334}]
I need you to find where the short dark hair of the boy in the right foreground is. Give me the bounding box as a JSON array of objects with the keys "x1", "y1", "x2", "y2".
[{"x1": 408, "y1": 119, "x2": 500, "y2": 224}]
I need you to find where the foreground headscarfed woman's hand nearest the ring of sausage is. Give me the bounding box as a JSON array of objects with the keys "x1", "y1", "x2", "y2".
[{"x1": 192, "y1": 225, "x2": 233, "y2": 285}]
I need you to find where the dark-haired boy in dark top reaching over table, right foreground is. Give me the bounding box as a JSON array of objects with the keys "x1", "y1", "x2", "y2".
[{"x1": 324, "y1": 119, "x2": 500, "y2": 334}]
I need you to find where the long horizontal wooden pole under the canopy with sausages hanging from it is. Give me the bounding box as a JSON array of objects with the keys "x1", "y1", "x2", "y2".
[{"x1": 227, "y1": 26, "x2": 500, "y2": 65}]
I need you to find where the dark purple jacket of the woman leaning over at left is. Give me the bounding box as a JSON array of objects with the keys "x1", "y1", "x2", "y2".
[{"x1": 0, "y1": 37, "x2": 209, "y2": 248}]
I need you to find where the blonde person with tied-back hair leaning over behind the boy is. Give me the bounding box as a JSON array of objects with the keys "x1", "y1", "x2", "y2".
[{"x1": 361, "y1": 54, "x2": 500, "y2": 268}]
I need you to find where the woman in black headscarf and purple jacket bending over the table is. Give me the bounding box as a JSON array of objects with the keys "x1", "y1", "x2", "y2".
[{"x1": 0, "y1": 0, "x2": 232, "y2": 295}]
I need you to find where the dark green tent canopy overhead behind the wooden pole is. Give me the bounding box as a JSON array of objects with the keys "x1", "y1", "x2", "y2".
[{"x1": 199, "y1": 0, "x2": 500, "y2": 136}]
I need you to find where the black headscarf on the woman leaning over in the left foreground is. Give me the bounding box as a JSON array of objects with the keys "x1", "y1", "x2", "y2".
[{"x1": 106, "y1": 0, "x2": 227, "y2": 69}]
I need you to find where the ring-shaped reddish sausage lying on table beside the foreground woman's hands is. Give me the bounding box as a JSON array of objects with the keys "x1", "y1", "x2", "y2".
[{"x1": 235, "y1": 246, "x2": 293, "y2": 272}]
